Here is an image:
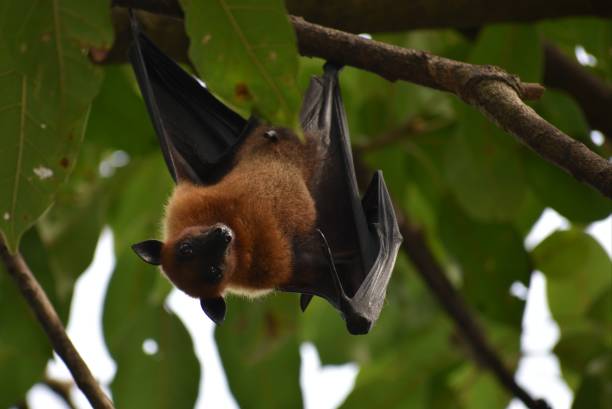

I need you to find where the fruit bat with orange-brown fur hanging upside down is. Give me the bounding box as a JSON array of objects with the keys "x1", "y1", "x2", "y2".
[{"x1": 129, "y1": 16, "x2": 402, "y2": 334}]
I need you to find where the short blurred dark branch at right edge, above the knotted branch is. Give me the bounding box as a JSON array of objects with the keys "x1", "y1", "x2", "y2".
[{"x1": 544, "y1": 42, "x2": 612, "y2": 139}]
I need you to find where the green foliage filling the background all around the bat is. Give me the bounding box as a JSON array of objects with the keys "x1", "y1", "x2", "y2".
[{"x1": 0, "y1": 0, "x2": 612, "y2": 408}]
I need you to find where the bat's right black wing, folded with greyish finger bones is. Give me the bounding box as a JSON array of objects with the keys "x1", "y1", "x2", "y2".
[{"x1": 283, "y1": 63, "x2": 402, "y2": 334}]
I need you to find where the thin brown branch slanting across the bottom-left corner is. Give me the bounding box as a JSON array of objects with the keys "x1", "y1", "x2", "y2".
[{"x1": 0, "y1": 238, "x2": 113, "y2": 409}]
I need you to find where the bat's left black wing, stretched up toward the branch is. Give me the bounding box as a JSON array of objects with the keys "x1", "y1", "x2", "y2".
[{"x1": 129, "y1": 12, "x2": 255, "y2": 184}]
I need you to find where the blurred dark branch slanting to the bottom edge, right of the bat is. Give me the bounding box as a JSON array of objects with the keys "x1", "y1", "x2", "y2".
[{"x1": 400, "y1": 217, "x2": 549, "y2": 409}]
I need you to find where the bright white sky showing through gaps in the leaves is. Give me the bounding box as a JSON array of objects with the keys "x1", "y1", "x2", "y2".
[{"x1": 28, "y1": 209, "x2": 612, "y2": 409}]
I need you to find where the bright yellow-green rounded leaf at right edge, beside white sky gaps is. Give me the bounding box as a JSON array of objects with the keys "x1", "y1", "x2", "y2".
[{"x1": 532, "y1": 230, "x2": 612, "y2": 330}]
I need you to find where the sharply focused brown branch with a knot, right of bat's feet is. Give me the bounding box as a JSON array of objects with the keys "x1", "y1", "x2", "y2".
[{"x1": 111, "y1": 0, "x2": 612, "y2": 198}]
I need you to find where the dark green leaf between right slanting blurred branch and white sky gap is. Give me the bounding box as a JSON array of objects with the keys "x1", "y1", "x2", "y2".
[{"x1": 438, "y1": 200, "x2": 531, "y2": 328}]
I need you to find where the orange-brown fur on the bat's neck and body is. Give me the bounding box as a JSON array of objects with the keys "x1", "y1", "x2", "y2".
[{"x1": 162, "y1": 127, "x2": 317, "y2": 298}]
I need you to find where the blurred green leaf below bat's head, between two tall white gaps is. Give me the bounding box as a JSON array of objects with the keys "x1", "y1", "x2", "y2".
[{"x1": 104, "y1": 253, "x2": 200, "y2": 409}]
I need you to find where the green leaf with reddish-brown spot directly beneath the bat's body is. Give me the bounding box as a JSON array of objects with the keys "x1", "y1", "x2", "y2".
[{"x1": 215, "y1": 294, "x2": 302, "y2": 408}]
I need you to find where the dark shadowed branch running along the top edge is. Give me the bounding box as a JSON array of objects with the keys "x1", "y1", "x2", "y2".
[{"x1": 112, "y1": 0, "x2": 612, "y2": 33}]
